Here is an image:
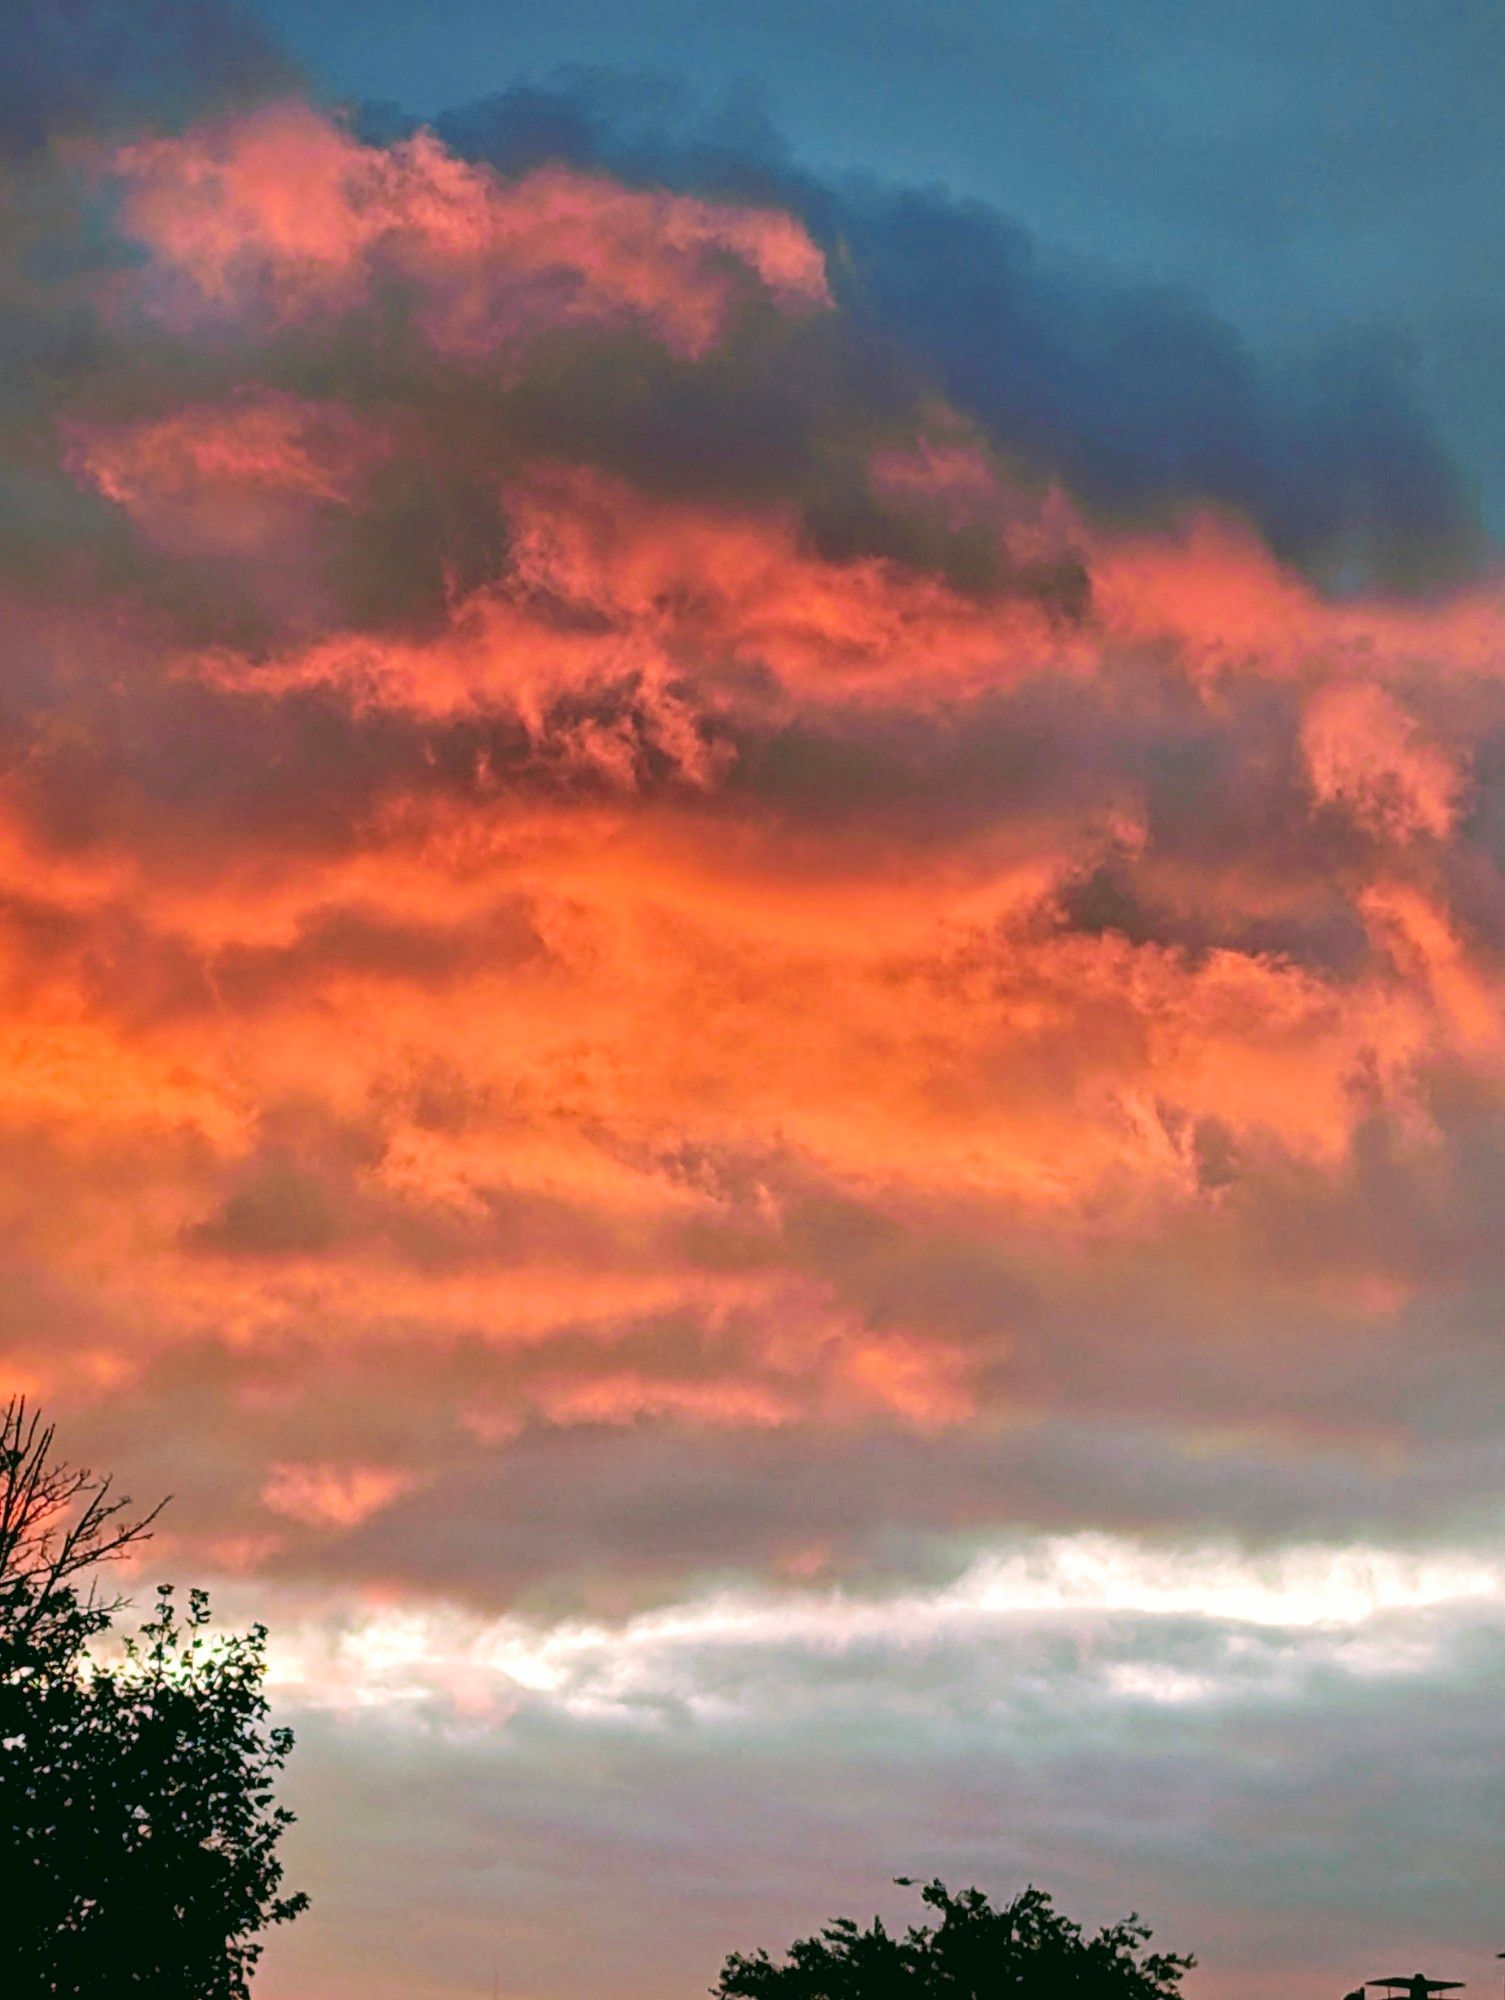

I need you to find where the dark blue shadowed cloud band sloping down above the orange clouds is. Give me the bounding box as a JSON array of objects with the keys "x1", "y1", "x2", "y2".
[{"x1": 438, "y1": 68, "x2": 1483, "y2": 600}]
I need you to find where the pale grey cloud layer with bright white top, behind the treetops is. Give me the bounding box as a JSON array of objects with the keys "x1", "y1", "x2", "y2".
[{"x1": 238, "y1": 1542, "x2": 1499, "y2": 2000}]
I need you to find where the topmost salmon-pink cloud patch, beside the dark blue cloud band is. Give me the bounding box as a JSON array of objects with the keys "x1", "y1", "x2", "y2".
[{"x1": 114, "y1": 102, "x2": 829, "y2": 358}]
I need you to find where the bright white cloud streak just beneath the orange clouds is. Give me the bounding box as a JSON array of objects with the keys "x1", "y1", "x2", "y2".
[{"x1": 256, "y1": 1534, "x2": 1505, "y2": 1722}]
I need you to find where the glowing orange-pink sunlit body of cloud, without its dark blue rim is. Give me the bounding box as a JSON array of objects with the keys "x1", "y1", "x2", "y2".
[{"x1": 0, "y1": 82, "x2": 1505, "y2": 1608}]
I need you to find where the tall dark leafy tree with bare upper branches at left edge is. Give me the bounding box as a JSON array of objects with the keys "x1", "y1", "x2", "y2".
[{"x1": 0, "y1": 1402, "x2": 306, "y2": 2000}]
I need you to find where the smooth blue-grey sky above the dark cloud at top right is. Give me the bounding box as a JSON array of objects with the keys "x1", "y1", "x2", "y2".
[{"x1": 262, "y1": 0, "x2": 1505, "y2": 544}]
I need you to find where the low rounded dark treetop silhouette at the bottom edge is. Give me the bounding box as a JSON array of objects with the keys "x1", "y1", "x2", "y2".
[{"x1": 712, "y1": 1876, "x2": 1195, "y2": 2000}]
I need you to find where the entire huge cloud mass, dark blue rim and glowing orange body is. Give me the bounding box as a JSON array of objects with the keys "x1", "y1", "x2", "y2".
[{"x1": 0, "y1": 6, "x2": 1505, "y2": 1992}]
